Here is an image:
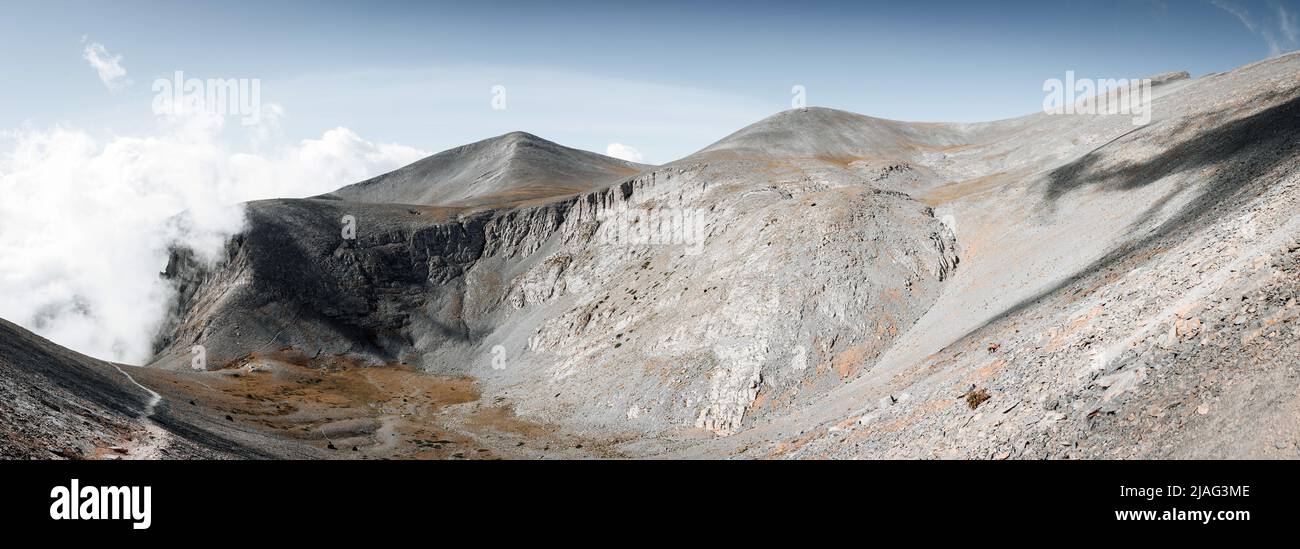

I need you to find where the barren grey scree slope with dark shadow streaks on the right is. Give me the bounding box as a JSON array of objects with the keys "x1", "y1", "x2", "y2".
[{"x1": 693, "y1": 55, "x2": 1300, "y2": 458}]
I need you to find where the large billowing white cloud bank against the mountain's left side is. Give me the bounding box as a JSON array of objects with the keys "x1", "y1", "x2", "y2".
[{"x1": 0, "y1": 110, "x2": 426, "y2": 362}]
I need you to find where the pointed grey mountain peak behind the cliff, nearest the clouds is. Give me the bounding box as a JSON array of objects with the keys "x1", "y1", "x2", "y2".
[{"x1": 322, "y1": 131, "x2": 647, "y2": 206}]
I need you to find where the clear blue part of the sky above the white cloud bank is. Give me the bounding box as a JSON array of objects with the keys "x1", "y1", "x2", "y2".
[{"x1": 0, "y1": 0, "x2": 1300, "y2": 163}]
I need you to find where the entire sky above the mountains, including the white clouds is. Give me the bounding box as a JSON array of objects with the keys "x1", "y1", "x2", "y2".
[{"x1": 0, "y1": 0, "x2": 1300, "y2": 363}]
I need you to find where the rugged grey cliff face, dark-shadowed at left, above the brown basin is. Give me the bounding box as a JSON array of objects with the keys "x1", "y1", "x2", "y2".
[{"x1": 155, "y1": 145, "x2": 958, "y2": 442}]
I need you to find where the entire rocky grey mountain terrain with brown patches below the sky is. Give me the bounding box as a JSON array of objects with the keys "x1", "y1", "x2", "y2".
[{"x1": 0, "y1": 55, "x2": 1300, "y2": 459}]
